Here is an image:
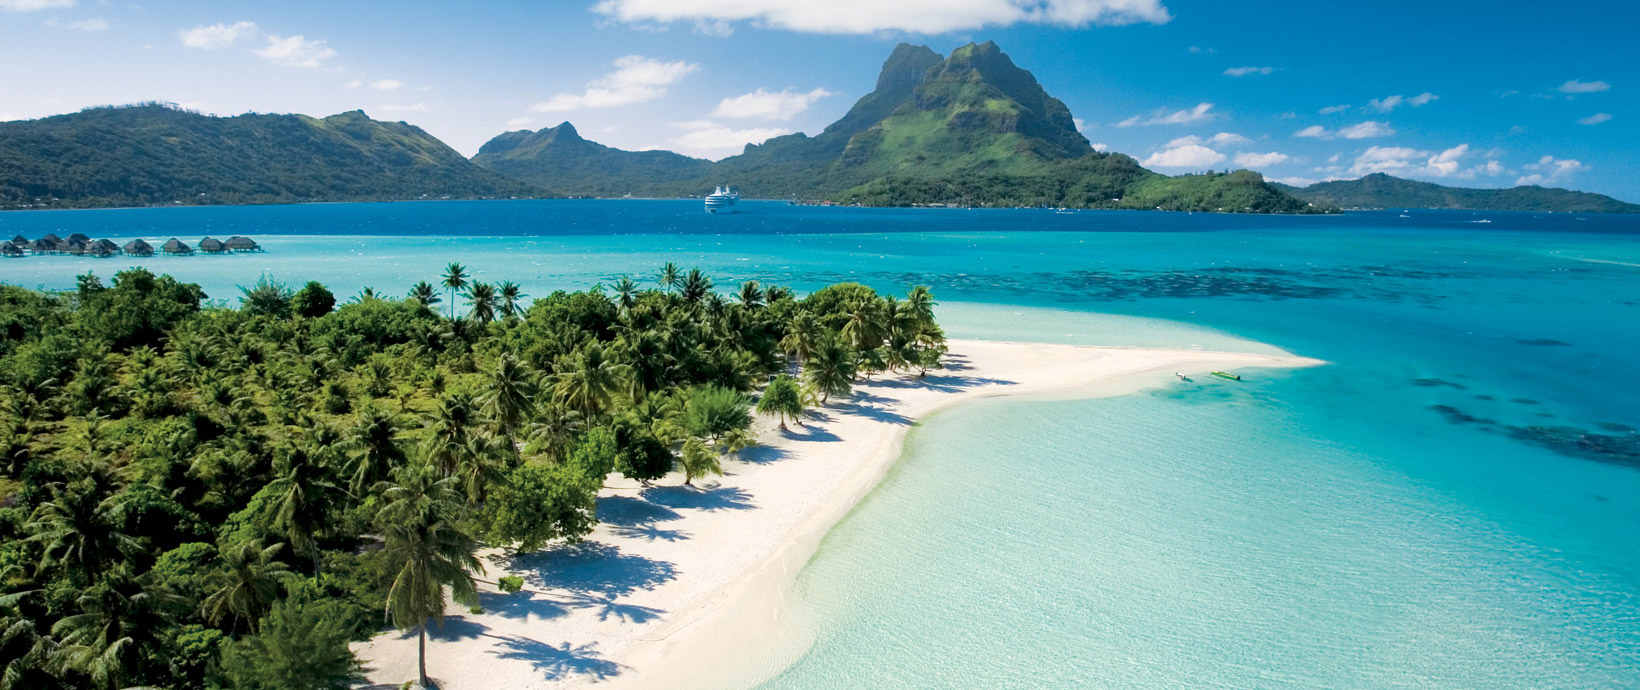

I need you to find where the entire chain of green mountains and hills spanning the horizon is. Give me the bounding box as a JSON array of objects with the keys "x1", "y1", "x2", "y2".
[{"x1": 0, "y1": 41, "x2": 1640, "y2": 213}]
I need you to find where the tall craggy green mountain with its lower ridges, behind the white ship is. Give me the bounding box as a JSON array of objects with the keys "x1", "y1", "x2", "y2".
[{"x1": 474, "y1": 41, "x2": 1319, "y2": 213}]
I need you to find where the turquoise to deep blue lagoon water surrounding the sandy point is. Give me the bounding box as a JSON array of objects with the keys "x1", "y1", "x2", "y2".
[{"x1": 0, "y1": 202, "x2": 1640, "y2": 688}]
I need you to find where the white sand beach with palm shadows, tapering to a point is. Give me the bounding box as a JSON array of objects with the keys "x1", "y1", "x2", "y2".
[{"x1": 354, "y1": 341, "x2": 1322, "y2": 690}]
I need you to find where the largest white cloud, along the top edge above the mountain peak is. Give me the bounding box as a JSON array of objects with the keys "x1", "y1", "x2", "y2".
[{"x1": 592, "y1": 0, "x2": 1173, "y2": 34}]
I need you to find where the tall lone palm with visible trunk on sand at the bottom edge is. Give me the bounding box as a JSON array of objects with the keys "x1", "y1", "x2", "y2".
[{"x1": 382, "y1": 465, "x2": 484, "y2": 687}]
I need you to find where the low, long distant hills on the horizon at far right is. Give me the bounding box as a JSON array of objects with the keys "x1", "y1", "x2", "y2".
[{"x1": 1278, "y1": 172, "x2": 1640, "y2": 213}]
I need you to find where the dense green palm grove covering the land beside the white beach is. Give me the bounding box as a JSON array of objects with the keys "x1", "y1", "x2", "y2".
[{"x1": 0, "y1": 264, "x2": 945, "y2": 681}]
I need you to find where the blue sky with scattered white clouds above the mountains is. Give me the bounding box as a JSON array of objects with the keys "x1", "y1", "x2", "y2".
[{"x1": 0, "y1": 0, "x2": 1640, "y2": 202}]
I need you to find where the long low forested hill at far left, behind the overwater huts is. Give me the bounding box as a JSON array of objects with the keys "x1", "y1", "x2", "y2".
[{"x1": 0, "y1": 103, "x2": 544, "y2": 208}]
